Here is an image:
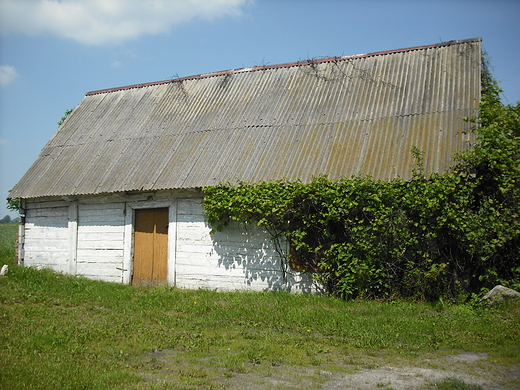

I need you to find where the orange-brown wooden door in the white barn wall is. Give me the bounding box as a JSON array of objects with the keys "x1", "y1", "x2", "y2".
[{"x1": 132, "y1": 208, "x2": 168, "y2": 284}]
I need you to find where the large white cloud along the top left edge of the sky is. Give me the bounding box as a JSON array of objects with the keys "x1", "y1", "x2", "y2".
[{"x1": 0, "y1": 0, "x2": 251, "y2": 45}]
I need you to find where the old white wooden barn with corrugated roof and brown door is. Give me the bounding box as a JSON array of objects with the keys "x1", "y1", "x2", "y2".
[{"x1": 10, "y1": 38, "x2": 482, "y2": 292}]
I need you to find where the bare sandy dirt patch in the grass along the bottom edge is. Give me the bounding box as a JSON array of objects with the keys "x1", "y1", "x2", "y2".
[{"x1": 133, "y1": 351, "x2": 520, "y2": 390}]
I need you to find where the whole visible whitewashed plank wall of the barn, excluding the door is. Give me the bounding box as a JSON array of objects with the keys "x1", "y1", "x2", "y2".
[{"x1": 24, "y1": 192, "x2": 313, "y2": 292}]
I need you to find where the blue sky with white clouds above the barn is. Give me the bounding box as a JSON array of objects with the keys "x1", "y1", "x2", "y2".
[{"x1": 0, "y1": 0, "x2": 520, "y2": 218}]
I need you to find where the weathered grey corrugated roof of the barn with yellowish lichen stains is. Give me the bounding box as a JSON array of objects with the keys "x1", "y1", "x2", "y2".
[{"x1": 11, "y1": 38, "x2": 481, "y2": 198}]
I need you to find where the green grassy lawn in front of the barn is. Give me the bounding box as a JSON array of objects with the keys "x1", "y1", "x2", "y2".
[{"x1": 0, "y1": 225, "x2": 520, "y2": 390}]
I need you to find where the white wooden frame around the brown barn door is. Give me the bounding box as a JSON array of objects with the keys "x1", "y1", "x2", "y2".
[{"x1": 123, "y1": 200, "x2": 177, "y2": 286}]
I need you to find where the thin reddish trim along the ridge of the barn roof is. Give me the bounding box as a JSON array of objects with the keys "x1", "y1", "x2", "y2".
[{"x1": 85, "y1": 38, "x2": 482, "y2": 96}]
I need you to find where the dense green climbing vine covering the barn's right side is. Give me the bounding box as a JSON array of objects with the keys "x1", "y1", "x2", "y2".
[{"x1": 204, "y1": 61, "x2": 520, "y2": 300}]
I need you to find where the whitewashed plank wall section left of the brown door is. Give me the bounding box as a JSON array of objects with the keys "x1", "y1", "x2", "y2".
[{"x1": 24, "y1": 199, "x2": 125, "y2": 282}]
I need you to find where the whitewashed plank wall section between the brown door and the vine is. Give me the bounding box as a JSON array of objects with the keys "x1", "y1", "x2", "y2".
[{"x1": 176, "y1": 199, "x2": 313, "y2": 292}]
